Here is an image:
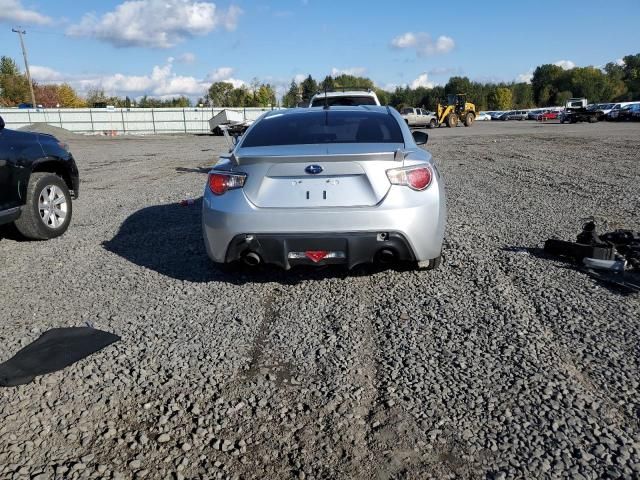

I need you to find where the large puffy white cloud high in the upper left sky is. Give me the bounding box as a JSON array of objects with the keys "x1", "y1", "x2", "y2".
[{"x1": 67, "y1": 0, "x2": 242, "y2": 48}]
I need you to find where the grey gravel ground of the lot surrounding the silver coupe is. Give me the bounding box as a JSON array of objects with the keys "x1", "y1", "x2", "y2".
[{"x1": 0, "y1": 122, "x2": 640, "y2": 479}]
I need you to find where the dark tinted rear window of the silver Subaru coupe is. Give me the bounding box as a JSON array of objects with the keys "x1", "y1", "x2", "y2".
[{"x1": 241, "y1": 110, "x2": 404, "y2": 147}]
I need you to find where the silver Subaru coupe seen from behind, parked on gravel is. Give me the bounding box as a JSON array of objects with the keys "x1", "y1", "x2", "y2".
[{"x1": 202, "y1": 105, "x2": 447, "y2": 269}]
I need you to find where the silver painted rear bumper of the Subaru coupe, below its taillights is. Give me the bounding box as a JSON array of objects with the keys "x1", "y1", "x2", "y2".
[{"x1": 202, "y1": 177, "x2": 446, "y2": 268}]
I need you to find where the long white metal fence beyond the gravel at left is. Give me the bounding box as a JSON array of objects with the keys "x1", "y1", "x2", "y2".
[{"x1": 0, "y1": 107, "x2": 280, "y2": 135}]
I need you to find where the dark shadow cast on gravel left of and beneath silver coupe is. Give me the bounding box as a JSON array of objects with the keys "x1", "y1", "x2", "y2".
[{"x1": 102, "y1": 198, "x2": 400, "y2": 285}]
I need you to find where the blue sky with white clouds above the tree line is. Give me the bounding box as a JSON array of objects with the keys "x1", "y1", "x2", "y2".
[{"x1": 0, "y1": 0, "x2": 640, "y2": 98}]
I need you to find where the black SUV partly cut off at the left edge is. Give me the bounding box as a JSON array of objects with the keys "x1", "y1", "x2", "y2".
[{"x1": 0, "y1": 117, "x2": 80, "y2": 240}]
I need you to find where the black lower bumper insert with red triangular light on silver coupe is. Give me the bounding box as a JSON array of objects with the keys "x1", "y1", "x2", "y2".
[{"x1": 226, "y1": 232, "x2": 415, "y2": 270}]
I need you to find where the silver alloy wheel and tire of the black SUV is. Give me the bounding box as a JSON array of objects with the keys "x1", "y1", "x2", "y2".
[{"x1": 15, "y1": 172, "x2": 73, "y2": 240}]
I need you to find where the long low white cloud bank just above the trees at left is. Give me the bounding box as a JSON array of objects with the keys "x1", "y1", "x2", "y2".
[{"x1": 31, "y1": 57, "x2": 246, "y2": 98}]
